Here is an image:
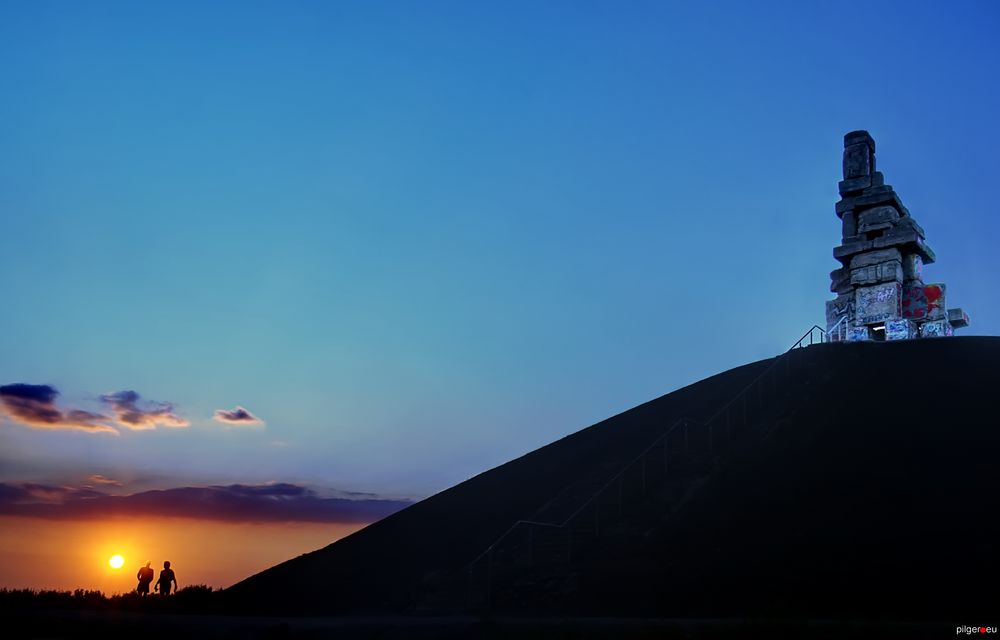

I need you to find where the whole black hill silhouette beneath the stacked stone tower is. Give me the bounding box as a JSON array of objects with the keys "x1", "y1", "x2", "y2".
[{"x1": 225, "y1": 337, "x2": 1000, "y2": 619}]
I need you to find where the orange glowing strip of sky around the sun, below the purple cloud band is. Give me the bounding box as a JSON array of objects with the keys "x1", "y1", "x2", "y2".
[{"x1": 0, "y1": 516, "x2": 363, "y2": 595}]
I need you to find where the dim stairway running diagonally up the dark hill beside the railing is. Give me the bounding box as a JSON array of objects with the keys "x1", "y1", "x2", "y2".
[{"x1": 415, "y1": 342, "x2": 822, "y2": 612}]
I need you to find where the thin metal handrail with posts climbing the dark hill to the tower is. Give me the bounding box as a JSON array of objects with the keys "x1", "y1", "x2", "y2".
[{"x1": 466, "y1": 324, "x2": 828, "y2": 607}]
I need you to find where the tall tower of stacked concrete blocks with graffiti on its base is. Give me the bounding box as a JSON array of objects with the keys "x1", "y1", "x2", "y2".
[{"x1": 826, "y1": 131, "x2": 969, "y2": 341}]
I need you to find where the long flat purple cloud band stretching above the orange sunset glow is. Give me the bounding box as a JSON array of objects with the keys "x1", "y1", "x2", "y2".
[{"x1": 0, "y1": 483, "x2": 411, "y2": 524}]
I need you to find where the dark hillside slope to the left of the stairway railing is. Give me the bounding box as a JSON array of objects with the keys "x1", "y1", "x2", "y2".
[{"x1": 226, "y1": 350, "x2": 772, "y2": 615}]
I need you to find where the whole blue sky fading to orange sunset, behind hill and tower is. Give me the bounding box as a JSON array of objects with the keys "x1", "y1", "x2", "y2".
[{"x1": 0, "y1": 1, "x2": 1000, "y2": 590}]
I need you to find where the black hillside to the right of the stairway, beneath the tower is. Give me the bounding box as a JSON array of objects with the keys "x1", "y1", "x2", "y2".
[{"x1": 500, "y1": 338, "x2": 1000, "y2": 621}]
